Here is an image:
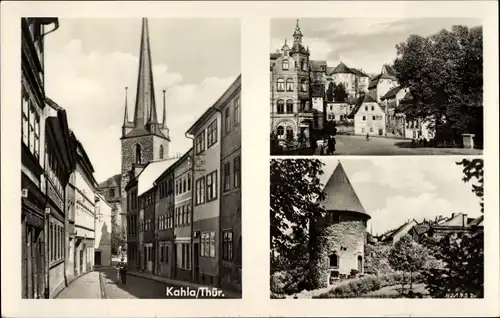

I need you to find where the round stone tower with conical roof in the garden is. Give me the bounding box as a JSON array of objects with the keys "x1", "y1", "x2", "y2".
[{"x1": 310, "y1": 163, "x2": 370, "y2": 288}]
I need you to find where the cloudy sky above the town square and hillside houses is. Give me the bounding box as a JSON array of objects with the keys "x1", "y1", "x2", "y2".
[{"x1": 271, "y1": 18, "x2": 481, "y2": 74}]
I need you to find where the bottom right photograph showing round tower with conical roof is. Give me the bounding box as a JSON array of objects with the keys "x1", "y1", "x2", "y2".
[{"x1": 270, "y1": 156, "x2": 484, "y2": 299}]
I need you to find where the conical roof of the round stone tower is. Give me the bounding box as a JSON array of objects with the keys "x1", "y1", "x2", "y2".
[{"x1": 320, "y1": 162, "x2": 370, "y2": 218}]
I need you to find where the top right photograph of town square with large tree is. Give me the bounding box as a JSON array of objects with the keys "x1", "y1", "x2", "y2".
[{"x1": 269, "y1": 17, "x2": 483, "y2": 155}]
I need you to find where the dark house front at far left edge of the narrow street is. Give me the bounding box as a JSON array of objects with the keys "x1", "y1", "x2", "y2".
[{"x1": 21, "y1": 18, "x2": 59, "y2": 298}]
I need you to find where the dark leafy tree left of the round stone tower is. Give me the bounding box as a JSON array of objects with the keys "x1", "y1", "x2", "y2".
[{"x1": 270, "y1": 159, "x2": 325, "y2": 273}]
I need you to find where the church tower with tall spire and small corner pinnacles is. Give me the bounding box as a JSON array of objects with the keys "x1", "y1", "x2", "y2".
[{"x1": 120, "y1": 18, "x2": 170, "y2": 229}]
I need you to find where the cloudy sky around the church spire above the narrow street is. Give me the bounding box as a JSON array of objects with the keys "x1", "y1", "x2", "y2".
[{"x1": 45, "y1": 18, "x2": 241, "y2": 182}]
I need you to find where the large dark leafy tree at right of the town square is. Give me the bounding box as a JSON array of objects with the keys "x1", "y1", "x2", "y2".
[{"x1": 394, "y1": 26, "x2": 483, "y2": 144}]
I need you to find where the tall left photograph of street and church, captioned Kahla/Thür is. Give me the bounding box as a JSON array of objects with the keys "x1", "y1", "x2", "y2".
[{"x1": 21, "y1": 17, "x2": 242, "y2": 299}]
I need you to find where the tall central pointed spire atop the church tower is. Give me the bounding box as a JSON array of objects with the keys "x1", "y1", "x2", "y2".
[{"x1": 134, "y1": 18, "x2": 158, "y2": 128}]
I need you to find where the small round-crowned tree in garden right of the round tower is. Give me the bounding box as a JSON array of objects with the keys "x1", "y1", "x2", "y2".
[{"x1": 389, "y1": 234, "x2": 426, "y2": 289}]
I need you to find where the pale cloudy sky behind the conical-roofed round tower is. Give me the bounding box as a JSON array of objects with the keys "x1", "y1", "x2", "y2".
[{"x1": 314, "y1": 156, "x2": 481, "y2": 235}]
